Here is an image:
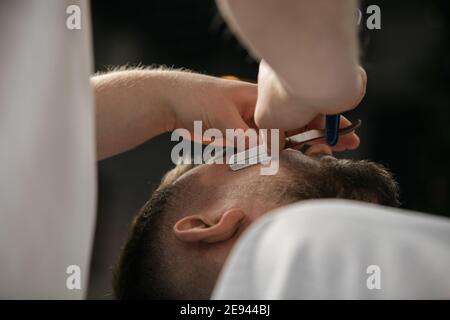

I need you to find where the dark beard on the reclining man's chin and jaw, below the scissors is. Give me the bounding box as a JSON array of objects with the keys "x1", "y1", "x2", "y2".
[{"x1": 280, "y1": 156, "x2": 400, "y2": 207}]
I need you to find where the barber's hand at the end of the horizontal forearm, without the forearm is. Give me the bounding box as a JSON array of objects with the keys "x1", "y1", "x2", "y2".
[{"x1": 168, "y1": 72, "x2": 257, "y2": 145}]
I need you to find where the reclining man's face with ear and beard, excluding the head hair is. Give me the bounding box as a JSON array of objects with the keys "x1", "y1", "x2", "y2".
[{"x1": 167, "y1": 145, "x2": 398, "y2": 298}]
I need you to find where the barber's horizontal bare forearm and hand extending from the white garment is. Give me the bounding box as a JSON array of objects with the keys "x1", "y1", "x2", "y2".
[{"x1": 91, "y1": 70, "x2": 359, "y2": 160}]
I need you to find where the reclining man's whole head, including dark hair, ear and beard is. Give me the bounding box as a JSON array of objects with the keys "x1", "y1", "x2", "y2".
[{"x1": 117, "y1": 144, "x2": 398, "y2": 299}]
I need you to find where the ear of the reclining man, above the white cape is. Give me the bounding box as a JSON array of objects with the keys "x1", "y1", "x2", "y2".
[{"x1": 173, "y1": 208, "x2": 245, "y2": 243}]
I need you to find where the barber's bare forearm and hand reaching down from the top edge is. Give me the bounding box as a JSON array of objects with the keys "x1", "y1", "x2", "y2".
[{"x1": 217, "y1": 0, "x2": 367, "y2": 143}]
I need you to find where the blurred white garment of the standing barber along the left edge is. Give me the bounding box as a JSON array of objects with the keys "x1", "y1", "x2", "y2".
[{"x1": 0, "y1": 0, "x2": 96, "y2": 299}]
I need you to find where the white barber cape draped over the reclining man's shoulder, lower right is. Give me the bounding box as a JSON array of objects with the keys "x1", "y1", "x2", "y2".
[{"x1": 213, "y1": 200, "x2": 450, "y2": 299}]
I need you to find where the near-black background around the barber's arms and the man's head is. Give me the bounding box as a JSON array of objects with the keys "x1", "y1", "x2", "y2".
[{"x1": 89, "y1": 0, "x2": 450, "y2": 299}]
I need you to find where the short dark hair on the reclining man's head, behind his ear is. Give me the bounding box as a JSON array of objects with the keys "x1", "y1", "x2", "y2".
[{"x1": 113, "y1": 165, "x2": 194, "y2": 300}]
